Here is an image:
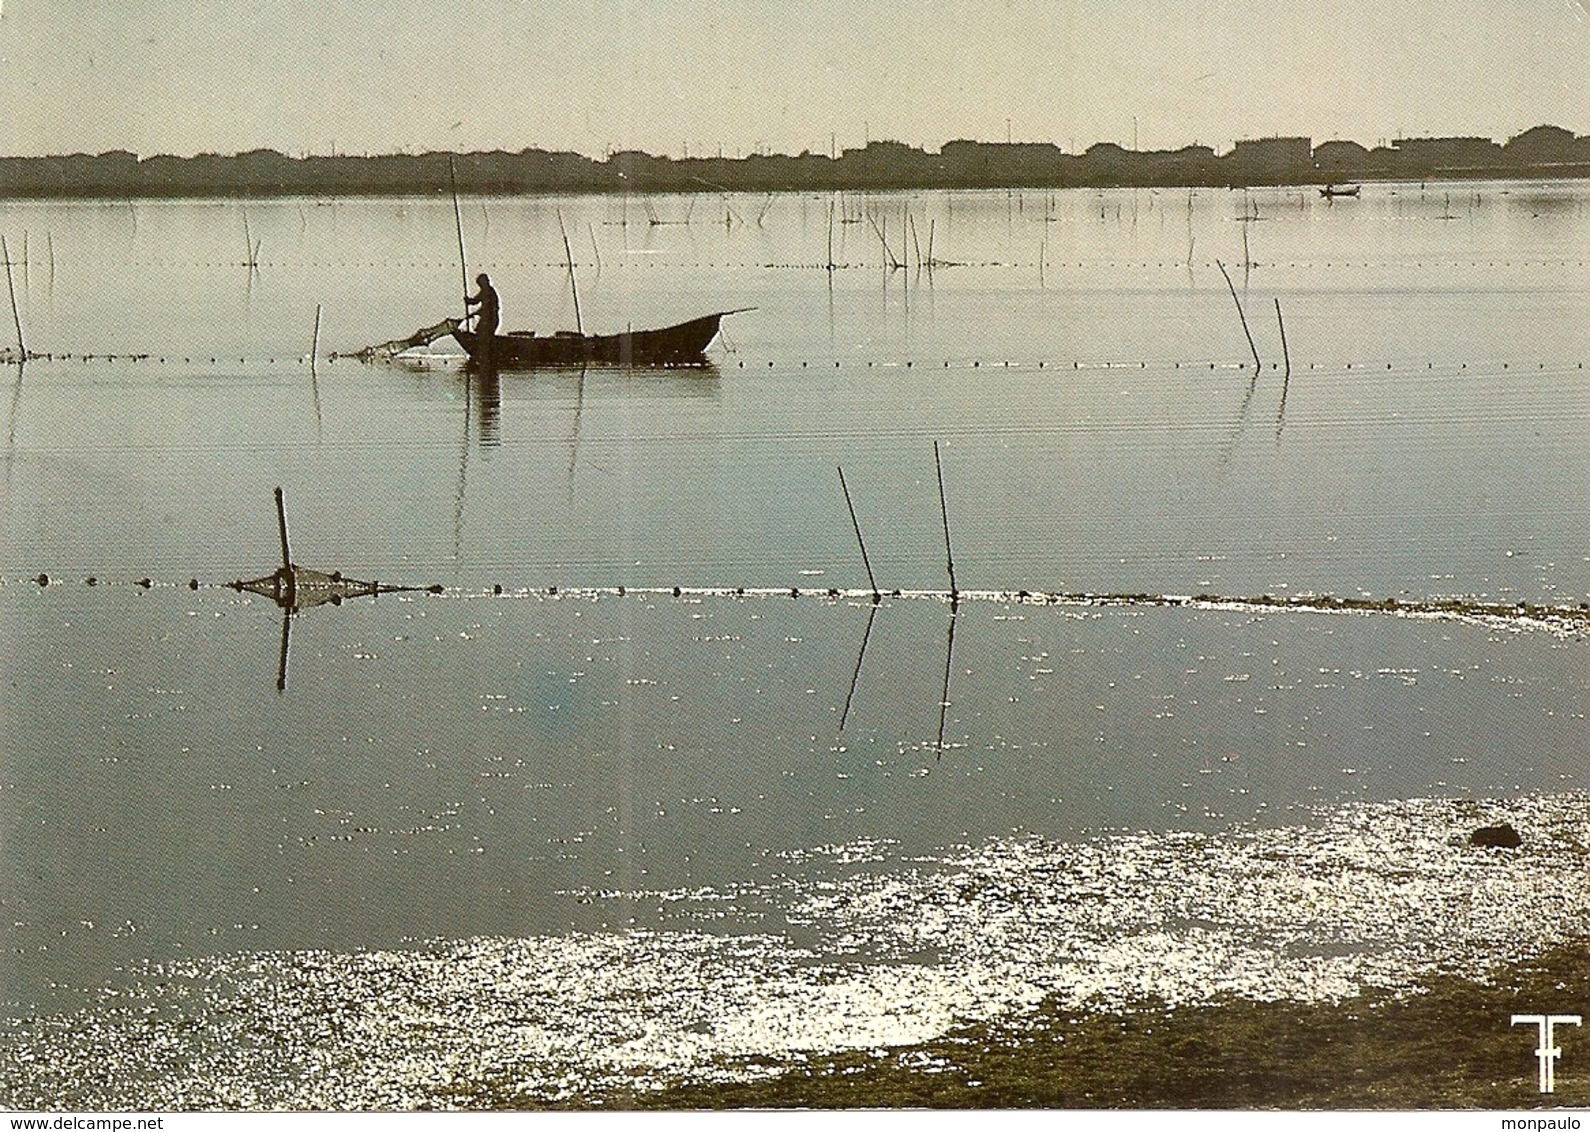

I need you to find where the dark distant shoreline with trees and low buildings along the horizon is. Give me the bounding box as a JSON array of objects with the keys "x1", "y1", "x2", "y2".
[{"x1": 0, "y1": 126, "x2": 1590, "y2": 200}]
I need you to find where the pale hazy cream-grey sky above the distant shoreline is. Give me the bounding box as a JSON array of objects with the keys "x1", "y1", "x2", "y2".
[{"x1": 0, "y1": 0, "x2": 1590, "y2": 157}]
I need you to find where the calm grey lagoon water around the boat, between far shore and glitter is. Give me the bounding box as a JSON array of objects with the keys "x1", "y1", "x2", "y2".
[{"x1": 0, "y1": 183, "x2": 1590, "y2": 1093}]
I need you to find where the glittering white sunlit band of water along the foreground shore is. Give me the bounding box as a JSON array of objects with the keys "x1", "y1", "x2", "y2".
[{"x1": 0, "y1": 793, "x2": 1590, "y2": 1108}]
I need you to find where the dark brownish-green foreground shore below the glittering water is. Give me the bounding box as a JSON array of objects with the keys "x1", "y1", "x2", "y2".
[{"x1": 553, "y1": 941, "x2": 1590, "y2": 1111}]
